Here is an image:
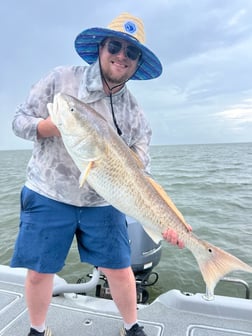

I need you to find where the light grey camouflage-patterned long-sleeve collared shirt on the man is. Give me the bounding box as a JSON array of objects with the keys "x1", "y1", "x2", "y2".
[{"x1": 12, "y1": 62, "x2": 151, "y2": 206}]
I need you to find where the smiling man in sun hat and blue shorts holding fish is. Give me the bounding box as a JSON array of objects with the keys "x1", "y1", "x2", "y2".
[{"x1": 11, "y1": 13, "x2": 183, "y2": 336}]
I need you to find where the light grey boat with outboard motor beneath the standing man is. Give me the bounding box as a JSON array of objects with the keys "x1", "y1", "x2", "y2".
[{"x1": 0, "y1": 218, "x2": 252, "y2": 336}]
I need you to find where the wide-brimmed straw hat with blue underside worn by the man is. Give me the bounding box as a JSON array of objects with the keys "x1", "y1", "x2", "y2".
[{"x1": 75, "y1": 13, "x2": 162, "y2": 80}]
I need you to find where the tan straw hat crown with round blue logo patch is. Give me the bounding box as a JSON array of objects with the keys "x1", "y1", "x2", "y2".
[{"x1": 108, "y1": 13, "x2": 145, "y2": 43}]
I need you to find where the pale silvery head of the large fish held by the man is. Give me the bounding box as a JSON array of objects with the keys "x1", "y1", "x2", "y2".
[{"x1": 47, "y1": 93, "x2": 106, "y2": 167}]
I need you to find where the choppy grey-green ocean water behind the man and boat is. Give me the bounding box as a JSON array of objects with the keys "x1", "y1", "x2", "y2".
[{"x1": 0, "y1": 143, "x2": 252, "y2": 300}]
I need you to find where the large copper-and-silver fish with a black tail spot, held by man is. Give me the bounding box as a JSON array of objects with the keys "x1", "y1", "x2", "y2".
[{"x1": 48, "y1": 93, "x2": 252, "y2": 295}]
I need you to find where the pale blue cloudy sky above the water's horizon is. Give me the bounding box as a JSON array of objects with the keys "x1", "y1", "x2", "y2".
[{"x1": 0, "y1": 0, "x2": 252, "y2": 150}]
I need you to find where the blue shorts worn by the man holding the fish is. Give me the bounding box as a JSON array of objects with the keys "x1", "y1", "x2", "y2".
[{"x1": 11, "y1": 187, "x2": 130, "y2": 273}]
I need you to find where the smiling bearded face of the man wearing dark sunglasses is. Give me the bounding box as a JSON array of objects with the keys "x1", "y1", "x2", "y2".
[{"x1": 99, "y1": 38, "x2": 141, "y2": 86}]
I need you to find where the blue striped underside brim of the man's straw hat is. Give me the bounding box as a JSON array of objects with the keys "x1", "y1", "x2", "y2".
[{"x1": 75, "y1": 28, "x2": 162, "y2": 80}]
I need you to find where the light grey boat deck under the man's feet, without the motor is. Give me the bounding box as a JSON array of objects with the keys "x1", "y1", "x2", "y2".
[{"x1": 0, "y1": 265, "x2": 252, "y2": 336}]
